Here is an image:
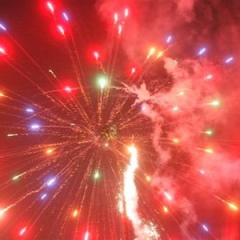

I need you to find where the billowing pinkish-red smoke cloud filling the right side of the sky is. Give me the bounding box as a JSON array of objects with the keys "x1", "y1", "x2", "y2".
[{"x1": 98, "y1": 0, "x2": 240, "y2": 239}]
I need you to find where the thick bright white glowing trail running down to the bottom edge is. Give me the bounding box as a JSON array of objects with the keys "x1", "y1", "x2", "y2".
[{"x1": 124, "y1": 145, "x2": 160, "y2": 240}]
